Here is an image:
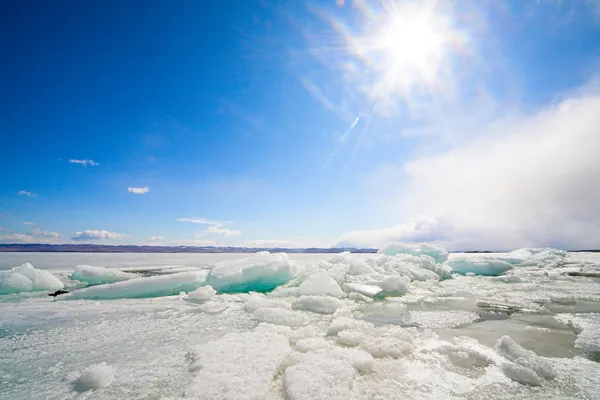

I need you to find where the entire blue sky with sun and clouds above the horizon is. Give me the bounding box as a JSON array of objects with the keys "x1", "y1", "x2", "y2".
[{"x1": 0, "y1": 0, "x2": 600, "y2": 249}]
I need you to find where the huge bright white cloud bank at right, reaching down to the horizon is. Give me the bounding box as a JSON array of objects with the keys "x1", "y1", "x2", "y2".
[{"x1": 341, "y1": 84, "x2": 600, "y2": 249}]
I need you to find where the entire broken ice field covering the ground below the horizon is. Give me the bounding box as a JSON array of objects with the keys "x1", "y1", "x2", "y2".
[{"x1": 0, "y1": 244, "x2": 600, "y2": 400}]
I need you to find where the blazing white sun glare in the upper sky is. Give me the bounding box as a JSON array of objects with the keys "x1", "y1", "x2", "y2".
[{"x1": 349, "y1": 1, "x2": 462, "y2": 104}]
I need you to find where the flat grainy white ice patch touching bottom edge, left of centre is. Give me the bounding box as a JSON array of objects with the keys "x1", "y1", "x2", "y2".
[{"x1": 185, "y1": 332, "x2": 292, "y2": 400}]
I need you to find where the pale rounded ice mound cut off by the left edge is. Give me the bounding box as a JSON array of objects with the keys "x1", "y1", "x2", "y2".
[{"x1": 0, "y1": 263, "x2": 65, "y2": 295}]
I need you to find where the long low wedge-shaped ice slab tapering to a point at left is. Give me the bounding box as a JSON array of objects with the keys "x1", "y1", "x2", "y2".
[{"x1": 57, "y1": 271, "x2": 206, "y2": 300}]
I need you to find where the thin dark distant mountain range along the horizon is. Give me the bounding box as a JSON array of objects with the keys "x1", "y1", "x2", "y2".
[{"x1": 0, "y1": 243, "x2": 377, "y2": 253}]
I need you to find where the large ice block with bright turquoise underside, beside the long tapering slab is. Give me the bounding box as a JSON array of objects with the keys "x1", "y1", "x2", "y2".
[{"x1": 208, "y1": 252, "x2": 296, "y2": 293}]
